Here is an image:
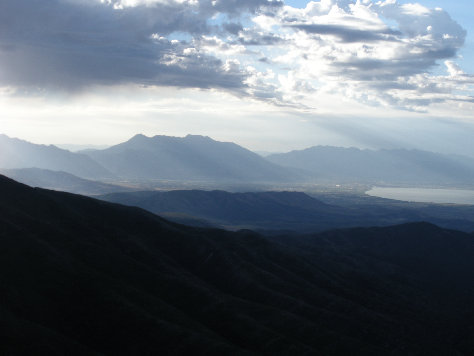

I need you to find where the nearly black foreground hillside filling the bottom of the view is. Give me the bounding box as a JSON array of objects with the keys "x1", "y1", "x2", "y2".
[{"x1": 0, "y1": 176, "x2": 474, "y2": 355}]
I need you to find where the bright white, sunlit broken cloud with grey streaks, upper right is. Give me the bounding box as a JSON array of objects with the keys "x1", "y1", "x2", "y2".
[{"x1": 235, "y1": 0, "x2": 470, "y2": 111}]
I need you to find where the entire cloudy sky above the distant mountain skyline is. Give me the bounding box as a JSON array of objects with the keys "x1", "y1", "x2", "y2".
[{"x1": 0, "y1": 0, "x2": 474, "y2": 156}]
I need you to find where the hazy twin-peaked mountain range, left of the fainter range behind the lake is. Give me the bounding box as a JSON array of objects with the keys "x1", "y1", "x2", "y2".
[{"x1": 0, "y1": 135, "x2": 301, "y2": 184}]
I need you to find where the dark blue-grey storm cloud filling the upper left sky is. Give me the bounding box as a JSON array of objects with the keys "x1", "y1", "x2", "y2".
[{"x1": 0, "y1": 0, "x2": 277, "y2": 90}]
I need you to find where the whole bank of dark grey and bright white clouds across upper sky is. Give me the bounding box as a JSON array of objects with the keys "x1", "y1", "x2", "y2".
[{"x1": 0, "y1": 0, "x2": 473, "y2": 111}]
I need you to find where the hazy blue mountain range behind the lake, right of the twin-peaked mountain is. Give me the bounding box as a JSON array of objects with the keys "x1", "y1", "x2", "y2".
[{"x1": 266, "y1": 146, "x2": 474, "y2": 184}]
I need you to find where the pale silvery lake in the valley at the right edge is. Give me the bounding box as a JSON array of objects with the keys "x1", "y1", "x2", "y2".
[{"x1": 366, "y1": 187, "x2": 474, "y2": 204}]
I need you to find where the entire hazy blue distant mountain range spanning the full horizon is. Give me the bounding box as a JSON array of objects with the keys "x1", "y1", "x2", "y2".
[{"x1": 0, "y1": 134, "x2": 474, "y2": 187}]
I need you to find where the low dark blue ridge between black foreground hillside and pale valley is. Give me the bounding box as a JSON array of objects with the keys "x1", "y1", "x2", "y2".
[{"x1": 100, "y1": 190, "x2": 474, "y2": 232}]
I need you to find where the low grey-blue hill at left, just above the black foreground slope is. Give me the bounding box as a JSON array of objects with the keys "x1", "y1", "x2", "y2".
[{"x1": 0, "y1": 168, "x2": 132, "y2": 195}]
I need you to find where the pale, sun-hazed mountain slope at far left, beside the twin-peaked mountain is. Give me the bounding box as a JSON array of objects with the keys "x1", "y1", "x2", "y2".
[{"x1": 0, "y1": 134, "x2": 112, "y2": 179}]
